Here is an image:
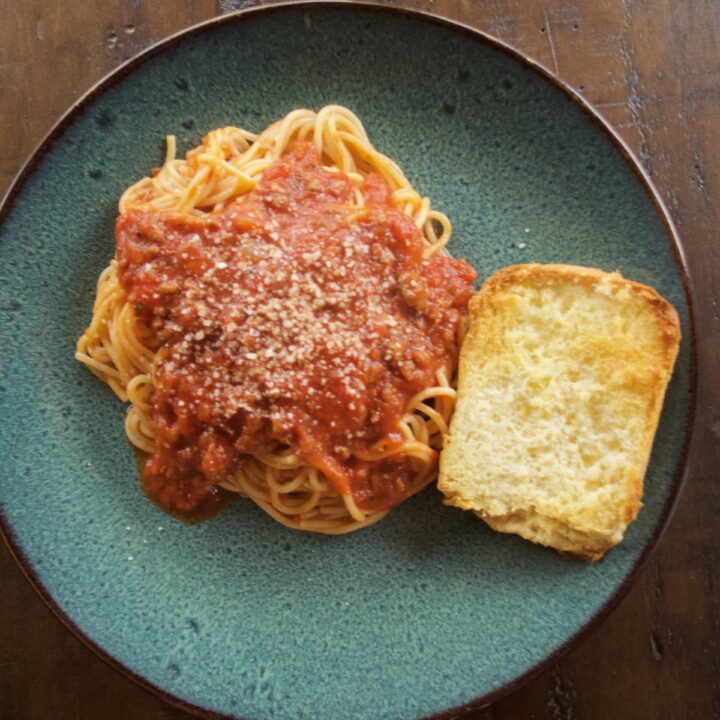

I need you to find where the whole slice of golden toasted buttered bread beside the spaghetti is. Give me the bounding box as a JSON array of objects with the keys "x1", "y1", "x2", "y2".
[{"x1": 439, "y1": 264, "x2": 680, "y2": 560}]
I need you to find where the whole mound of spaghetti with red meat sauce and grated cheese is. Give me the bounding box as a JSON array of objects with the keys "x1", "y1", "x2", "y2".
[{"x1": 76, "y1": 106, "x2": 475, "y2": 534}]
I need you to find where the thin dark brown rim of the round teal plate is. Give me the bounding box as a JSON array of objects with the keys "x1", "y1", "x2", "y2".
[{"x1": 0, "y1": 0, "x2": 699, "y2": 720}]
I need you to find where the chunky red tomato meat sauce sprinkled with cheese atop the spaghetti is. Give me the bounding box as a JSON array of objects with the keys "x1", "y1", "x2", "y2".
[{"x1": 116, "y1": 143, "x2": 476, "y2": 518}]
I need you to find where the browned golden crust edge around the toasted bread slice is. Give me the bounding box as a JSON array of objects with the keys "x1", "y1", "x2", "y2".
[{"x1": 438, "y1": 264, "x2": 680, "y2": 561}]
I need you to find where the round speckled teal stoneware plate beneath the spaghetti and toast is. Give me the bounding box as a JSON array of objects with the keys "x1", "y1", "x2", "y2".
[{"x1": 0, "y1": 3, "x2": 694, "y2": 720}]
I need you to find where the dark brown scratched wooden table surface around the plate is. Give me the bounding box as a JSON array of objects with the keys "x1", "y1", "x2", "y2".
[{"x1": 0, "y1": 0, "x2": 720, "y2": 720}]
